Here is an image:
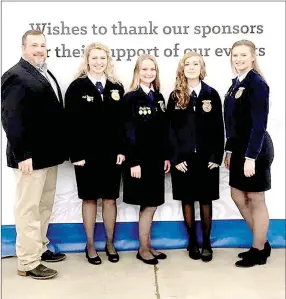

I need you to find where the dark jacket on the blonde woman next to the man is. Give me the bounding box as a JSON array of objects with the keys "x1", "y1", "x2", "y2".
[{"x1": 65, "y1": 77, "x2": 125, "y2": 163}]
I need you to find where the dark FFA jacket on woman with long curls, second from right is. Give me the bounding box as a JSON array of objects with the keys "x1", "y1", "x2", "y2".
[{"x1": 167, "y1": 81, "x2": 224, "y2": 165}]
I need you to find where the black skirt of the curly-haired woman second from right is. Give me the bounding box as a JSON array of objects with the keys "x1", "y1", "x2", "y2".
[{"x1": 171, "y1": 153, "x2": 219, "y2": 204}]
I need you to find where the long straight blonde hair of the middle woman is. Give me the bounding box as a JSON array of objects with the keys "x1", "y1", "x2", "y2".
[{"x1": 129, "y1": 54, "x2": 160, "y2": 91}]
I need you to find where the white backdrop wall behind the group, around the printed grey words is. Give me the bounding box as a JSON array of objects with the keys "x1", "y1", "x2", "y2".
[{"x1": 2, "y1": 2, "x2": 285, "y2": 224}]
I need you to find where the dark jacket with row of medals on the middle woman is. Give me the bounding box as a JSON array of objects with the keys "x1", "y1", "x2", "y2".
[{"x1": 124, "y1": 87, "x2": 170, "y2": 167}]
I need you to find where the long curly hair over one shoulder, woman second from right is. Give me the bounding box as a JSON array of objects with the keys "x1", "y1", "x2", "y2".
[{"x1": 174, "y1": 51, "x2": 207, "y2": 109}]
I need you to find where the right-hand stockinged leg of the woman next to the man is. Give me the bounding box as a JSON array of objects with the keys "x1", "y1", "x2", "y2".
[{"x1": 102, "y1": 199, "x2": 117, "y2": 254}]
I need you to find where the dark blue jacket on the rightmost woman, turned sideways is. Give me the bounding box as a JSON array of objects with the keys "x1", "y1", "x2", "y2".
[{"x1": 224, "y1": 70, "x2": 272, "y2": 159}]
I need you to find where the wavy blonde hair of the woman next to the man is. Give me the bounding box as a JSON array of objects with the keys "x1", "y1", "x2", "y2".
[{"x1": 75, "y1": 43, "x2": 121, "y2": 84}]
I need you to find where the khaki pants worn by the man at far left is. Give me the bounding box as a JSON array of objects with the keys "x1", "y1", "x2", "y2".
[{"x1": 14, "y1": 166, "x2": 57, "y2": 271}]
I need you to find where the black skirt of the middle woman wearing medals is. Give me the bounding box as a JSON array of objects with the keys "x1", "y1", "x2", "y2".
[{"x1": 123, "y1": 161, "x2": 165, "y2": 207}]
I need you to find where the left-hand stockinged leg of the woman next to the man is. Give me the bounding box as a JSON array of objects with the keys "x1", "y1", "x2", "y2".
[{"x1": 82, "y1": 200, "x2": 97, "y2": 258}]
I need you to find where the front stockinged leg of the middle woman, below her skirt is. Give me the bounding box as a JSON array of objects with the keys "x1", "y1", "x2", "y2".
[{"x1": 139, "y1": 207, "x2": 157, "y2": 260}]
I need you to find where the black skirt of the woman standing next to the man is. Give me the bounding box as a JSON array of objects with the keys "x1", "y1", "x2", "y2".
[{"x1": 74, "y1": 158, "x2": 121, "y2": 200}]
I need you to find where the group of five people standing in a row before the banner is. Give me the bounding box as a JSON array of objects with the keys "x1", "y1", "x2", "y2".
[{"x1": 2, "y1": 30, "x2": 274, "y2": 279}]
